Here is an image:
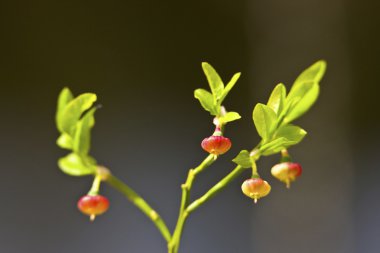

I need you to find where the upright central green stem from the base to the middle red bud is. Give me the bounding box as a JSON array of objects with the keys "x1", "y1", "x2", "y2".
[{"x1": 168, "y1": 154, "x2": 217, "y2": 253}]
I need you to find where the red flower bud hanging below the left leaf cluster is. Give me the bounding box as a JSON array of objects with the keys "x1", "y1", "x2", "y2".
[{"x1": 78, "y1": 195, "x2": 110, "y2": 221}]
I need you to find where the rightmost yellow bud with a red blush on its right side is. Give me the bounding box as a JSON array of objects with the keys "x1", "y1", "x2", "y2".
[{"x1": 271, "y1": 162, "x2": 302, "y2": 188}]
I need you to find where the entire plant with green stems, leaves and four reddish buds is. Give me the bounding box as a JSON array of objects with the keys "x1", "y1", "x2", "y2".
[{"x1": 56, "y1": 61, "x2": 326, "y2": 253}]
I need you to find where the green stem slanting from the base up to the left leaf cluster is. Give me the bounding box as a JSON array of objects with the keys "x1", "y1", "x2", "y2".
[{"x1": 105, "y1": 174, "x2": 171, "y2": 242}]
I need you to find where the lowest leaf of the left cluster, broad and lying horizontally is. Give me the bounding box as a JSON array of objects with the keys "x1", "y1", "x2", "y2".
[{"x1": 58, "y1": 153, "x2": 96, "y2": 176}]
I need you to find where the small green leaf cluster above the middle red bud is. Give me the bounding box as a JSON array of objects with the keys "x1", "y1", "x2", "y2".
[{"x1": 194, "y1": 62, "x2": 240, "y2": 122}]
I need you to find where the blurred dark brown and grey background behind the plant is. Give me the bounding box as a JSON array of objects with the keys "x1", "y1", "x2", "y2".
[{"x1": 0, "y1": 0, "x2": 380, "y2": 253}]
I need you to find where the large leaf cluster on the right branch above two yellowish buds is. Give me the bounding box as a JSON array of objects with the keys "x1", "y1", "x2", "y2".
[{"x1": 253, "y1": 61, "x2": 326, "y2": 155}]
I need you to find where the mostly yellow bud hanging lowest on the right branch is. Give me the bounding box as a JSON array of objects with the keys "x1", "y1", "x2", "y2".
[{"x1": 241, "y1": 178, "x2": 271, "y2": 203}]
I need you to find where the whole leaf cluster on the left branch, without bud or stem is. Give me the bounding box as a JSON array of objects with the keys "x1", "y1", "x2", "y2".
[{"x1": 56, "y1": 88, "x2": 96, "y2": 176}]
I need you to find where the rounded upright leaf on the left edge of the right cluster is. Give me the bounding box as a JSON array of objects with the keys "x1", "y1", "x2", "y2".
[{"x1": 252, "y1": 103, "x2": 277, "y2": 142}]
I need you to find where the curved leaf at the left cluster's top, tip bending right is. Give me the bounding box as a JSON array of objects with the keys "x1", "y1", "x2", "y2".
[{"x1": 58, "y1": 93, "x2": 96, "y2": 137}]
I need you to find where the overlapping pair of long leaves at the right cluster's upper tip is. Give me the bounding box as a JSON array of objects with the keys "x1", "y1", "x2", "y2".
[{"x1": 285, "y1": 61, "x2": 326, "y2": 123}]
